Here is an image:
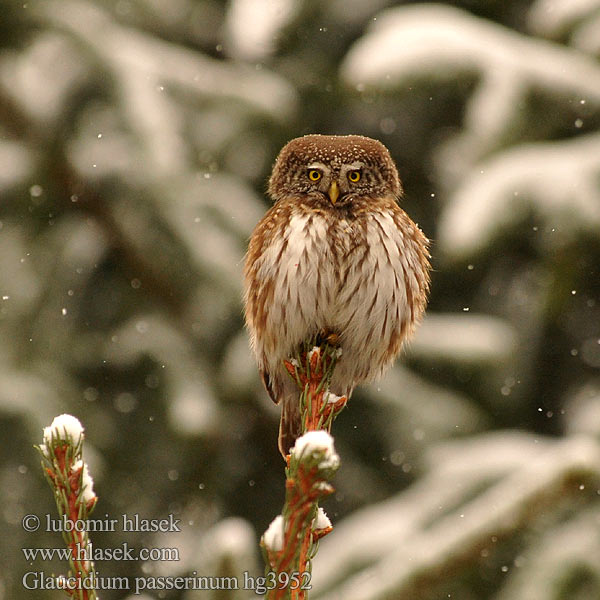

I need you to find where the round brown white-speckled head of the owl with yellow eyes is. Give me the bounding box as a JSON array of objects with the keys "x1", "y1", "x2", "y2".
[{"x1": 269, "y1": 135, "x2": 402, "y2": 207}]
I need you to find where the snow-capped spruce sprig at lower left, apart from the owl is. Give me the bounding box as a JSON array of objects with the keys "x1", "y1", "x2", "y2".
[{"x1": 36, "y1": 414, "x2": 98, "y2": 600}]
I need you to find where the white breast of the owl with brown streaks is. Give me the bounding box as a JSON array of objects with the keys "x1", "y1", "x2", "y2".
[{"x1": 255, "y1": 201, "x2": 427, "y2": 394}]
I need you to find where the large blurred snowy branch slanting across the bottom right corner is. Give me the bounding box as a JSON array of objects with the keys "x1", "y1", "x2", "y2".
[{"x1": 313, "y1": 432, "x2": 600, "y2": 600}]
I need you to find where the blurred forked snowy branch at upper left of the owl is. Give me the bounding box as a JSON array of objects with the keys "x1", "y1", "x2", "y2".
[{"x1": 32, "y1": 0, "x2": 296, "y2": 183}]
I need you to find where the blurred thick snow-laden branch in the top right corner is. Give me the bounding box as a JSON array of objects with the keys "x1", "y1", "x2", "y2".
[{"x1": 341, "y1": 5, "x2": 600, "y2": 98}]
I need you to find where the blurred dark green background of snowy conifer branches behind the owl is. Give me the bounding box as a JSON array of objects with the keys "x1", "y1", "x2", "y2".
[{"x1": 0, "y1": 0, "x2": 600, "y2": 600}]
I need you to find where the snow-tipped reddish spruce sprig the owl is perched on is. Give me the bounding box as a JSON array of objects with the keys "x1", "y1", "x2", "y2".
[{"x1": 261, "y1": 342, "x2": 347, "y2": 600}]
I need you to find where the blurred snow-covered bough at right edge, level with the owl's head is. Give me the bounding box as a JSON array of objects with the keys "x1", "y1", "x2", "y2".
[{"x1": 438, "y1": 134, "x2": 600, "y2": 258}]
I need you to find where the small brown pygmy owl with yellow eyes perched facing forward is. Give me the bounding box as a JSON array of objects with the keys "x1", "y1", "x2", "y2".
[{"x1": 245, "y1": 135, "x2": 430, "y2": 456}]
